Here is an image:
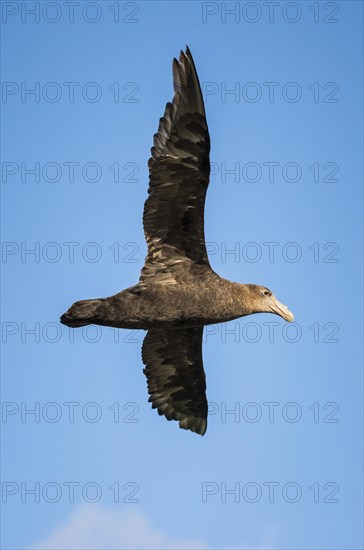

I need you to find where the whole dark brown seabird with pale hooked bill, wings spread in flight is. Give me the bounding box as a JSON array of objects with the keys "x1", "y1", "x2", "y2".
[{"x1": 60, "y1": 46, "x2": 293, "y2": 435}]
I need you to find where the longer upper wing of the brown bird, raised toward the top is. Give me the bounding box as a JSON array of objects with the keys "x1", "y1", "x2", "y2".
[{"x1": 141, "y1": 48, "x2": 210, "y2": 281}]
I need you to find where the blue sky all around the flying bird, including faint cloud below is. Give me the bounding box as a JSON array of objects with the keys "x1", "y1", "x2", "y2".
[{"x1": 1, "y1": 1, "x2": 363, "y2": 550}]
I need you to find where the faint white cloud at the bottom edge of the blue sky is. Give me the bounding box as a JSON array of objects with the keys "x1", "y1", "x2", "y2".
[{"x1": 30, "y1": 504, "x2": 207, "y2": 550}]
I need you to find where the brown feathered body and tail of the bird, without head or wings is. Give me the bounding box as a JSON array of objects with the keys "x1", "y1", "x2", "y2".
[{"x1": 63, "y1": 278, "x2": 270, "y2": 330}]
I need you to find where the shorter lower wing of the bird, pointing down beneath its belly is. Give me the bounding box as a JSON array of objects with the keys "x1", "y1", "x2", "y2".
[{"x1": 142, "y1": 327, "x2": 207, "y2": 435}]
